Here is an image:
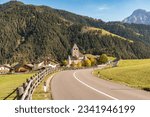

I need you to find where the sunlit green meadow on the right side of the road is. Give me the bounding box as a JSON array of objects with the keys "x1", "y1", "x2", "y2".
[{"x1": 95, "y1": 59, "x2": 150, "y2": 90}]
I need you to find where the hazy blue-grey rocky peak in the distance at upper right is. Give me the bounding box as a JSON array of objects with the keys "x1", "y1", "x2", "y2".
[{"x1": 123, "y1": 9, "x2": 150, "y2": 25}]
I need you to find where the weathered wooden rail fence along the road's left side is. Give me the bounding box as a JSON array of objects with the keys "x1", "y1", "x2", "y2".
[{"x1": 16, "y1": 67, "x2": 58, "y2": 100}]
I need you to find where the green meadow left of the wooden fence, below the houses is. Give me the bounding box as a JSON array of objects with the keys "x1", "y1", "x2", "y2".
[{"x1": 0, "y1": 73, "x2": 34, "y2": 100}]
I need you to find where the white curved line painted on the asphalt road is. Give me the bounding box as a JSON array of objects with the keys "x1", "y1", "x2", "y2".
[{"x1": 73, "y1": 72, "x2": 119, "y2": 100}]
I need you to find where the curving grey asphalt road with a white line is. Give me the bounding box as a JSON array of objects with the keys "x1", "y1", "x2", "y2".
[{"x1": 51, "y1": 69, "x2": 150, "y2": 100}]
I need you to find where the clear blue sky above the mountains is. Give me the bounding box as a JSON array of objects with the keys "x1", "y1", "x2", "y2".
[{"x1": 0, "y1": 0, "x2": 150, "y2": 21}]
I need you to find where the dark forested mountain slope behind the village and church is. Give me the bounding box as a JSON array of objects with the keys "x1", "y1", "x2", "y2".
[{"x1": 0, "y1": 1, "x2": 150, "y2": 64}]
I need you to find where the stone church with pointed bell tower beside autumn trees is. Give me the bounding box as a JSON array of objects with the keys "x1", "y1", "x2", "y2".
[{"x1": 68, "y1": 44, "x2": 87, "y2": 67}]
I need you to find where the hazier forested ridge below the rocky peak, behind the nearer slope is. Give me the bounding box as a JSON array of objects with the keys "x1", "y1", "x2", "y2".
[{"x1": 102, "y1": 22, "x2": 150, "y2": 45}]
